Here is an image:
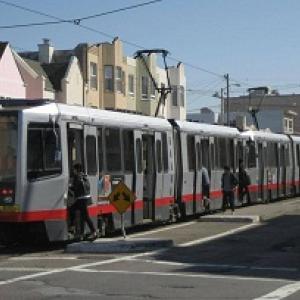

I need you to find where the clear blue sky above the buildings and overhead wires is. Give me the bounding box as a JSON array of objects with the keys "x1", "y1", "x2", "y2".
[{"x1": 0, "y1": 0, "x2": 300, "y2": 111}]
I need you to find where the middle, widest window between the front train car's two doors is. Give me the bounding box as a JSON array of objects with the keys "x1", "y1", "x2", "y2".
[{"x1": 105, "y1": 128, "x2": 121, "y2": 171}]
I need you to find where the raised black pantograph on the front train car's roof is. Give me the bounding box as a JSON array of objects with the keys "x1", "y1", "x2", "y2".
[{"x1": 134, "y1": 49, "x2": 172, "y2": 117}]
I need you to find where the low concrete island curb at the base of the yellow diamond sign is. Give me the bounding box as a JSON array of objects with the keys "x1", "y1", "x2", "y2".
[{"x1": 65, "y1": 238, "x2": 174, "y2": 253}]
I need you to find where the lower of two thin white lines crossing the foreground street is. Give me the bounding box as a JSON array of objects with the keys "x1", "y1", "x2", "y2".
[{"x1": 70, "y1": 268, "x2": 293, "y2": 282}]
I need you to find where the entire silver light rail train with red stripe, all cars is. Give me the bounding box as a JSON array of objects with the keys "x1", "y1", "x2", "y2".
[{"x1": 0, "y1": 99, "x2": 300, "y2": 242}]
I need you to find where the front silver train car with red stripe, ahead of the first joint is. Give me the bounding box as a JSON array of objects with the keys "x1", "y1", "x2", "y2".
[{"x1": 0, "y1": 100, "x2": 174, "y2": 241}]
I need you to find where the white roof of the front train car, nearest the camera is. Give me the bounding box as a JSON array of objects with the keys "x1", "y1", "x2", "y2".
[{"x1": 11, "y1": 102, "x2": 172, "y2": 131}]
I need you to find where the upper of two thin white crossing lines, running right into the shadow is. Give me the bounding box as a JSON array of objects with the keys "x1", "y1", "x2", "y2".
[{"x1": 128, "y1": 258, "x2": 300, "y2": 272}]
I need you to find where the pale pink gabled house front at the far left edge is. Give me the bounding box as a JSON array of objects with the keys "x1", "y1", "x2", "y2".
[{"x1": 0, "y1": 42, "x2": 26, "y2": 98}]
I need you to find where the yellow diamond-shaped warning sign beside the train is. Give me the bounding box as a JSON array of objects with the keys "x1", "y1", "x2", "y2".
[{"x1": 108, "y1": 181, "x2": 134, "y2": 214}]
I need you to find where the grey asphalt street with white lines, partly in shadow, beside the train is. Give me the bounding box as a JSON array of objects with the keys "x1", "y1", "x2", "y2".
[{"x1": 0, "y1": 198, "x2": 300, "y2": 300}]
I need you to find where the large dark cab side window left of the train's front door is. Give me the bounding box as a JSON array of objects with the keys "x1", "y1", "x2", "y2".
[{"x1": 27, "y1": 123, "x2": 62, "y2": 180}]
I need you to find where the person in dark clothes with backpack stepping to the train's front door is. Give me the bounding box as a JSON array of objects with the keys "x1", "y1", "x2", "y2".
[{"x1": 70, "y1": 163, "x2": 97, "y2": 239}]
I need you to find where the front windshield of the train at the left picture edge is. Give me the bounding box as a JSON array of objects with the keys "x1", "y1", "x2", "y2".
[{"x1": 0, "y1": 114, "x2": 18, "y2": 183}]
